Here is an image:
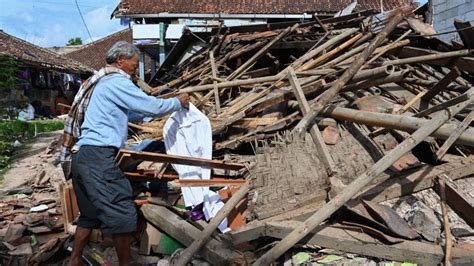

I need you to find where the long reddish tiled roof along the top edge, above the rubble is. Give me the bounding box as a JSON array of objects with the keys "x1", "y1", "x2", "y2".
[{"x1": 114, "y1": 0, "x2": 405, "y2": 15}]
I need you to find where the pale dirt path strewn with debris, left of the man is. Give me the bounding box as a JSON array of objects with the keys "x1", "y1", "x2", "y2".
[{"x1": 0, "y1": 130, "x2": 62, "y2": 195}]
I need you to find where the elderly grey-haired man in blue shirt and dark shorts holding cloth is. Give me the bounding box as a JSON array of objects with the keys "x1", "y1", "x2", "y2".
[{"x1": 63, "y1": 41, "x2": 189, "y2": 265}]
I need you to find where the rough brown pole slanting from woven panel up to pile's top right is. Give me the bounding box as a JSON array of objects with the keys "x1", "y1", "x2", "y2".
[{"x1": 294, "y1": 10, "x2": 404, "y2": 131}]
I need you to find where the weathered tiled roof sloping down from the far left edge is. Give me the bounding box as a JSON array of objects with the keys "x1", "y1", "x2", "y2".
[{"x1": 0, "y1": 30, "x2": 93, "y2": 73}]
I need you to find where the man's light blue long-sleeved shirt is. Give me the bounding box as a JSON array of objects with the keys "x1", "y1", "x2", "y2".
[{"x1": 76, "y1": 74, "x2": 181, "y2": 148}]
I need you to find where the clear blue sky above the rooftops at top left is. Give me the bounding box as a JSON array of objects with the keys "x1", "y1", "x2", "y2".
[{"x1": 0, "y1": 0, "x2": 125, "y2": 47}]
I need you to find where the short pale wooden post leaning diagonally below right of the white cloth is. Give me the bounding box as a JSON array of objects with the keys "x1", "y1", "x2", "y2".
[{"x1": 171, "y1": 182, "x2": 249, "y2": 266}]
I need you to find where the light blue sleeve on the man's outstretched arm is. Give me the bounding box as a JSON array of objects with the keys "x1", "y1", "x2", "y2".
[{"x1": 108, "y1": 77, "x2": 181, "y2": 116}]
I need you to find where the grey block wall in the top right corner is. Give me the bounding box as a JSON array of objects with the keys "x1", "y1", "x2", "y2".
[{"x1": 431, "y1": 0, "x2": 474, "y2": 41}]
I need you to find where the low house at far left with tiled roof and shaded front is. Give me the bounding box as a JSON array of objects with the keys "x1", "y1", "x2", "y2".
[{"x1": 0, "y1": 30, "x2": 94, "y2": 117}]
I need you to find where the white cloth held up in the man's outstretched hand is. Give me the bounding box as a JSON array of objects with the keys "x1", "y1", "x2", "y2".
[{"x1": 163, "y1": 103, "x2": 230, "y2": 232}]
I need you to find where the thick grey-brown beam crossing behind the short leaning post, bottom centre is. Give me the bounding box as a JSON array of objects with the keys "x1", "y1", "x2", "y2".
[{"x1": 140, "y1": 204, "x2": 245, "y2": 265}]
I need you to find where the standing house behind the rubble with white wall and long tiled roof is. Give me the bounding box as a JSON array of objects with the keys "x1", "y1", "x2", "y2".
[{"x1": 112, "y1": 0, "x2": 412, "y2": 81}]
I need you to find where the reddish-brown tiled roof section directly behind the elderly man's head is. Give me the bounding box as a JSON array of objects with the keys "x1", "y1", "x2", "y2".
[{"x1": 64, "y1": 29, "x2": 132, "y2": 70}]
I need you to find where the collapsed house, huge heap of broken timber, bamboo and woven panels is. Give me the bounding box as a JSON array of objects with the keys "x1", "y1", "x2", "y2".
[{"x1": 2, "y1": 2, "x2": 474, "y2": 265}]
